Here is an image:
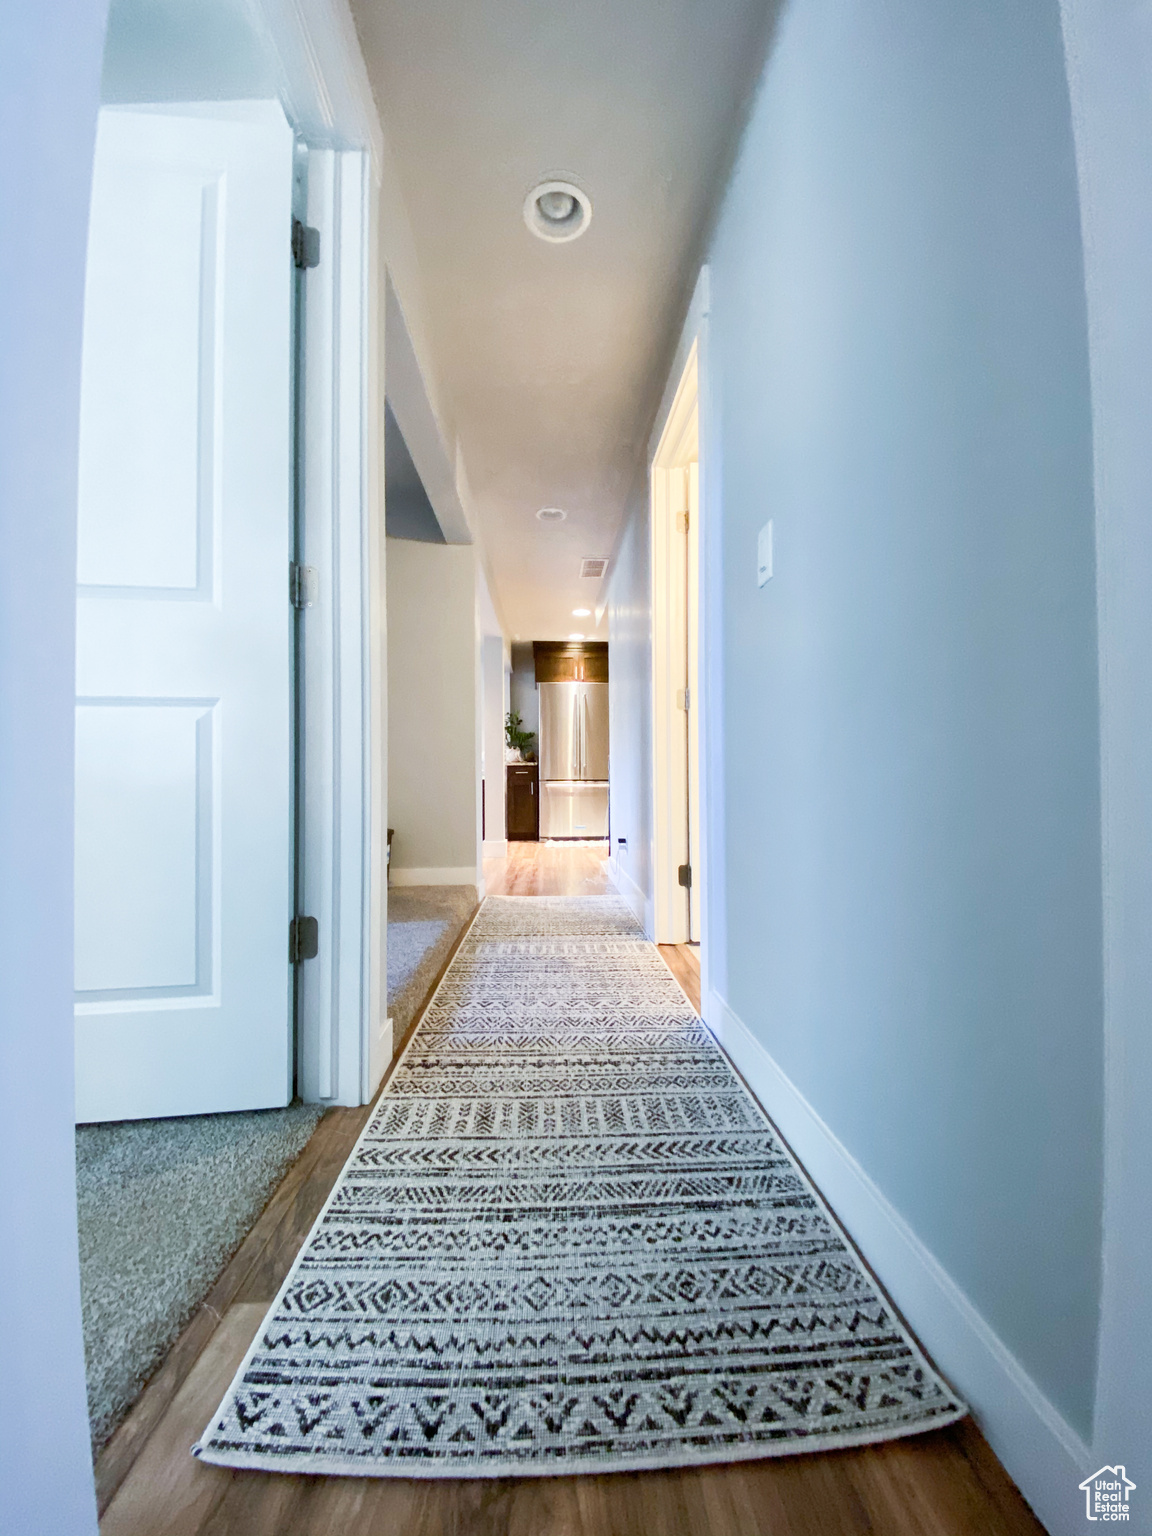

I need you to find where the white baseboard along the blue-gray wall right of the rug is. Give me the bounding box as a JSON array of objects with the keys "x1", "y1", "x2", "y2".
[{"x1": 705, "y1": 992, "x2": 1092, "y2": 1536}]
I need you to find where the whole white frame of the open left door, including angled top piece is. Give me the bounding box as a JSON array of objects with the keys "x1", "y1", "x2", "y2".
[{"x1": 255, "y1": 0, "x2": 392, "y2": 1104}]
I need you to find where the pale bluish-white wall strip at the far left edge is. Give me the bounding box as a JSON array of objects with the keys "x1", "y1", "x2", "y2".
[{"x1": 0, "y1": 0, "x2": 104, "y2": 1536}]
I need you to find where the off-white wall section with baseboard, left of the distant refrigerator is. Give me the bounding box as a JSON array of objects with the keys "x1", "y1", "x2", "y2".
[{"x1": 384, "y1": 539, "x2": 479, "y2": 885}]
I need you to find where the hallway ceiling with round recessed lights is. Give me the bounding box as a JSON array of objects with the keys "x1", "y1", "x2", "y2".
[{"x1": 353, "y1": 0, "x2": 770, "y2": 641}]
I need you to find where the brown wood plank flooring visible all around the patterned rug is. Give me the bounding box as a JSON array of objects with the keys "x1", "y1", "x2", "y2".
[{"x1": 97, "y1": 843, "x2": 1043, "y2": 1536}]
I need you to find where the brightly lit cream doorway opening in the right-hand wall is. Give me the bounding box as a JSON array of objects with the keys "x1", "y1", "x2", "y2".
[{"x1": 651, "y1": 344, "x2": 705, "y2": 945}]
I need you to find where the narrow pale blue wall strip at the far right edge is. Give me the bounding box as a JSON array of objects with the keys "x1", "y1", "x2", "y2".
[{"x1": 1061, "y1": 0, "x2": 1152, "y2": 1468}]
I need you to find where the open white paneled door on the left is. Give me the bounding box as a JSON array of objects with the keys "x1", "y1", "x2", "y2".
[{"x1": 75, "y1": 103, "x2": 293, "y2": 1121}]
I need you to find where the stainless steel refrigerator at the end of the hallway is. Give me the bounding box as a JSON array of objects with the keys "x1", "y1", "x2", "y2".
[{"x1": 539, "y1": 682, "x2": 608, "y2": 839}]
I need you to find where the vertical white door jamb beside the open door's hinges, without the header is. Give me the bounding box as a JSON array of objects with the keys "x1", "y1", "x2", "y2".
[{"x1": 296, "y1": 147, "x2": 373, "y2": 1104}]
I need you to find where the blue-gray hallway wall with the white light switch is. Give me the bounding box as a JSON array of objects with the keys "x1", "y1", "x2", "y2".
[{"x1": 711, "y1": 0, "x2": 1103, "y2": 1433}]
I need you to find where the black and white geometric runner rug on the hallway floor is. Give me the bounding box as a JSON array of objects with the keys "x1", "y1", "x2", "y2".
[{"x1": 195, "y1": 897, "x2": 966, "y2": 1478}]
